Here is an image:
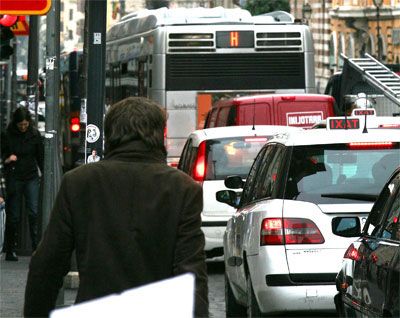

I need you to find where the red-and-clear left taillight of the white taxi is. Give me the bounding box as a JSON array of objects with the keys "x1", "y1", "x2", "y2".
[{"x1": 260, "y1": 218, "x2": 325, "y2": 245}]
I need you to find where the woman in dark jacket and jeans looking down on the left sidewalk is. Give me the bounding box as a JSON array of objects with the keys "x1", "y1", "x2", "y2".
[{"x1": 1, "y1": 107, "x2": 44, "y2": 261}]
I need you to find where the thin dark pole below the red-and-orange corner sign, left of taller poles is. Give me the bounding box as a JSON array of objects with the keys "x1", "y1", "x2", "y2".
[{"x1": 26, "y1": 15, "x2": 39, "y2": 127}]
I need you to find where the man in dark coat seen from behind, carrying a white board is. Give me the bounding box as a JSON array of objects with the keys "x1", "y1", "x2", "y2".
[{"x1": 24, "y1": 97, "x2": 208, "y2": 317}]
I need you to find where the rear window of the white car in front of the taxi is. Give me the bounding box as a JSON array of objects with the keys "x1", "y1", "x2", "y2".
[{"x1": 206, "y1": 136, "x2": 268, "y2": 180}]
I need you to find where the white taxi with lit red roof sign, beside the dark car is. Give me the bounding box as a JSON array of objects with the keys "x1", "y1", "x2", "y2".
[{"x1": 217, "y1": 117, "x2": 400, "y2": 317}]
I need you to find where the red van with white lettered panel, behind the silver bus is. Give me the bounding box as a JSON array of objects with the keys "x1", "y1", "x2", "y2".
[{"x1": 204, "y1": 94, "x2": 335, "y2": 128}]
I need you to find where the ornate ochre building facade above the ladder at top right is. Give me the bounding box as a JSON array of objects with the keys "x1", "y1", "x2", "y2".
[{"x1": 329, "y1": 0, "x2": 400, "y2": 71}]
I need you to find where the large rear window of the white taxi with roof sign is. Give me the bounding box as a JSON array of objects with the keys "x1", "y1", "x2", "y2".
[{"x1": 285, "y1": 144, "x2": 400, "y2": 204}]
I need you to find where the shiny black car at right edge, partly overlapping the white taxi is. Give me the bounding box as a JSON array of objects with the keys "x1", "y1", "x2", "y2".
[{"x1": 333, "y1": 167, "x2": 400, "y2": 317}]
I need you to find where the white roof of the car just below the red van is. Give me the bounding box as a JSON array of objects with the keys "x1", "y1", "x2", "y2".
[{"x1": 189, "y1": 125, "x2": 303, "y2": 147}]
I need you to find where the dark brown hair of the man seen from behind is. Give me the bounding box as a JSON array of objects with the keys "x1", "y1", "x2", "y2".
[{"x1": 104, "y1": 97, "x2": 166, "y2": 152}]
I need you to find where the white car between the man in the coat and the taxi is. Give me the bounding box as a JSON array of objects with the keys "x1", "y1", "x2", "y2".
[{"x1": 178, "y1": 125, "x2": 300, "y2": 258}]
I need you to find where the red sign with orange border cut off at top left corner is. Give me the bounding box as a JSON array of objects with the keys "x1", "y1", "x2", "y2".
[{"x1": 0, "y1": 0, "x2": 51, "y2": 15}]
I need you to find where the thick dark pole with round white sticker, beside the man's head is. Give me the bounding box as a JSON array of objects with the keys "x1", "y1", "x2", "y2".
[{"x1": 84, "y1": 0, "x2": 107, "y2": 158}]
